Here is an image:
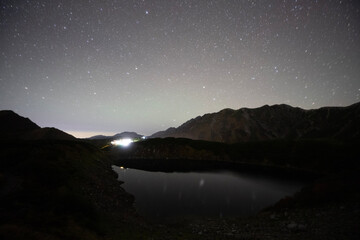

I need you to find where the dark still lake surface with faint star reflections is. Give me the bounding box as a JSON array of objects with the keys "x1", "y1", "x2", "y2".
[{"x1": 113, "y1": 166, "x2": 303, "y2": 218}]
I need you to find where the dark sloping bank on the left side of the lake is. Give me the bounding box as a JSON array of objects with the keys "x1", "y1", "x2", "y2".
[{"x1": 0, "y1": 141, "x2": 141, "y2": 239}]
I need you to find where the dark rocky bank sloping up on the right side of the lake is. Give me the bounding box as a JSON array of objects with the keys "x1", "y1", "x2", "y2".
[{"x1": 183, "y1": 172, "x2": 360, "y2": 239}]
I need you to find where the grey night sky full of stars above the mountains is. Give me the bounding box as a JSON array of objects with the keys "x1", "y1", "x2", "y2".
[{"x1": 0, "y1": 0, "x2": 360, "y2": 137}]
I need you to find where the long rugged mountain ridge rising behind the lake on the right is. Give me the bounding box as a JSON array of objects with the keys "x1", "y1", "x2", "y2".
[{"x1": 151, "y1": 103, "x2": 360, "y2": 143}]
